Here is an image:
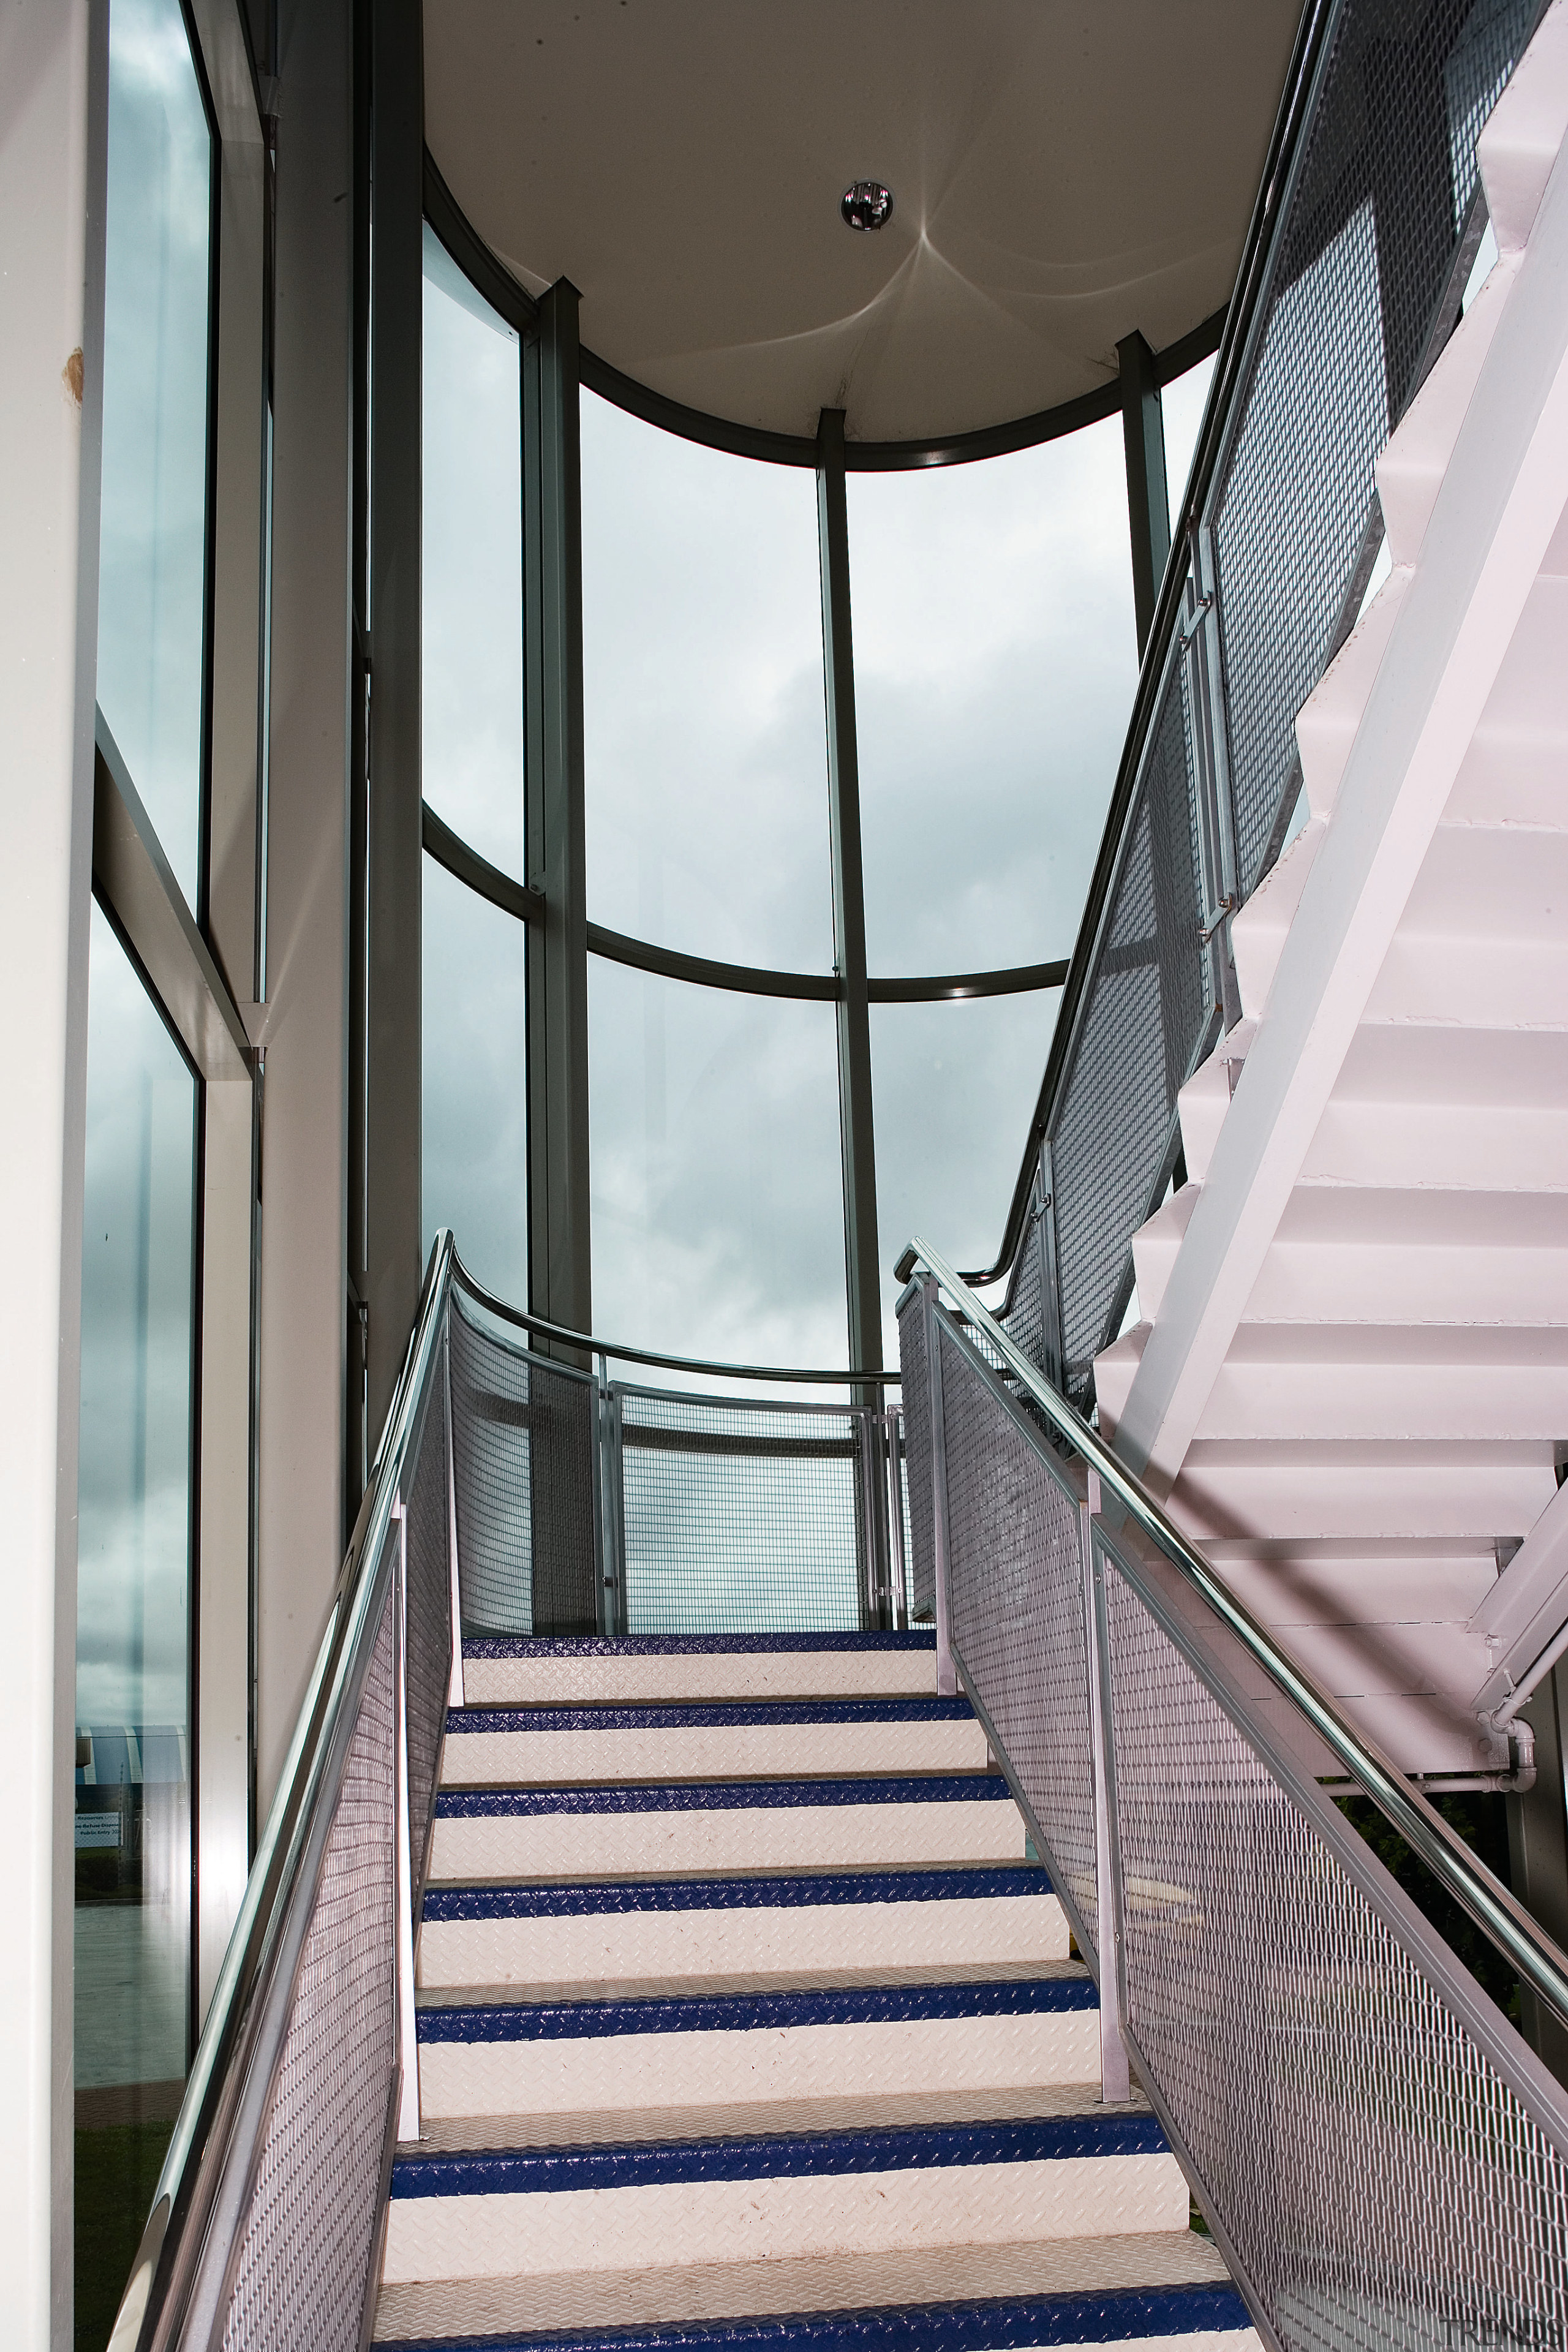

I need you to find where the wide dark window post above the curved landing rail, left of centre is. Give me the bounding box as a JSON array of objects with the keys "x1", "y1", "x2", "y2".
[{"x1": 522, "y1": 277, "x2": 592, "y2": 1362}]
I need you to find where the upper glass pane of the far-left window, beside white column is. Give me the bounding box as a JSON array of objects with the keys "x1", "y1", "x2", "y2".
[{"x1": 99, "y1": 0, "x2": 211, "y2": 908}]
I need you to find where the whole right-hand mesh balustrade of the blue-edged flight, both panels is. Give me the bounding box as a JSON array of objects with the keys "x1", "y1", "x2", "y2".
[{"x1": 898, "y1": 1256, "x2": 1568, "y2": 2352}]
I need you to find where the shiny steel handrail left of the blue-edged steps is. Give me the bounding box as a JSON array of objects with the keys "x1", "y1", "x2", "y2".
[{"x1": 110, "y1": 1232, "x2": 456, "y2": 2352}]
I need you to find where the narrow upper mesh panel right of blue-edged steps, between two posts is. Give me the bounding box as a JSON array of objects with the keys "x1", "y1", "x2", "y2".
[{"x1": 938, "y1": 1322, "x2": 1098, "y2": 1954}]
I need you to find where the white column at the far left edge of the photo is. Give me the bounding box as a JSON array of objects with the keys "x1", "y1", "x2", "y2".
[{"x1": 0, "y1": 0, "x2": 108, "y2": 2352}]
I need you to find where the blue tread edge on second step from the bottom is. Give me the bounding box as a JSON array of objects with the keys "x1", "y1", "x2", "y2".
[{"x1": 393, "y1": 2109, "x2": 1169, "y2": 2197}]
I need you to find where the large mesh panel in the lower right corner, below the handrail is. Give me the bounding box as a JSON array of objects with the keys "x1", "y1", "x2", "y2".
[{"x1": 1102, "y1": 1548, "x2": 1568, "y2": 2352}]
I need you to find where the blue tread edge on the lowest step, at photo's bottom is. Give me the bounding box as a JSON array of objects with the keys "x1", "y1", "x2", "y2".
[{"x1": 369, "y1": 2286, "x2": 1253, "y2": 2352}]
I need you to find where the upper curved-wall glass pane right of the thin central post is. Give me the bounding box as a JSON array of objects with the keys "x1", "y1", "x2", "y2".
[{"x1": 849, "y1": 417, "x2": 1138, "y2": 976}]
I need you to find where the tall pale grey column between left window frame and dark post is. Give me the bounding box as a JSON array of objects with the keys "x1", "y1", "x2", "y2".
[{"x1": 256, "y1": 0, "x2": 355, "y2": 1818}]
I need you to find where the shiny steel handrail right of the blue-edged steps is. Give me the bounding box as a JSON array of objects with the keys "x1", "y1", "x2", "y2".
[{"x1": 895, "y1": 1235, "x2": 1568, "y2": 2025}]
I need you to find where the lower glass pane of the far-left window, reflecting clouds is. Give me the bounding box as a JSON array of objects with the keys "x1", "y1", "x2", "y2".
[{"x1": 75, "y1": 905, "x2": 197, "y2": 2352}]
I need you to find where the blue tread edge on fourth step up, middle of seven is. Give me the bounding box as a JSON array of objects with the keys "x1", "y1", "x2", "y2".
[{"x1": 423, "y1": 1863, "x2": 1051, "y2": 1921}]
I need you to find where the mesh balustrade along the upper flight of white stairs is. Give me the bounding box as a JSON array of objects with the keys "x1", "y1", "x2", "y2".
[{"x1": 1006, "y1": 0, "x2": 1540, "y2": 1404}]
